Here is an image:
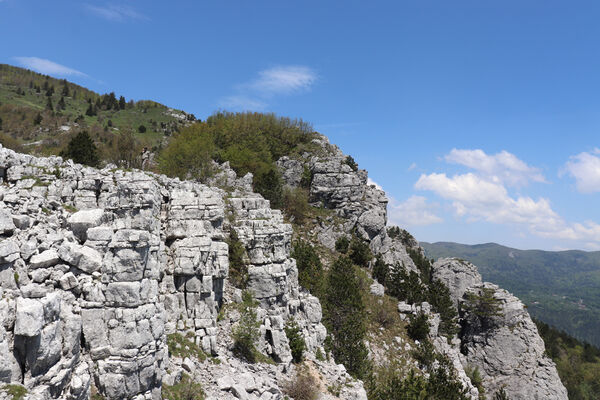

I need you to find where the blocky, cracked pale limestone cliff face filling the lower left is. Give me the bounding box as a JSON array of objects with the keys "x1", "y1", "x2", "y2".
[{"x1": 0, "y1": 147, "x2": 344, "y2": 399}]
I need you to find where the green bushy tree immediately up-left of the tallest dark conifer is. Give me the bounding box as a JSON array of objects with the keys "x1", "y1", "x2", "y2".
[{"x1": 291, "y1": 240, "x2": 326, "y2": 298}]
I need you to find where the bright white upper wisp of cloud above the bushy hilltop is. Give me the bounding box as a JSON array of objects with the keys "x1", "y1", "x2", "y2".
[{"x1": 248, "y1": 65, "x2": 317, "y2": 95}]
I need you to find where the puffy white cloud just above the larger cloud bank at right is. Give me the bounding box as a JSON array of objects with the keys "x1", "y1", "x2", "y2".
[{"x1": 444, "y1": 149, "x2": 546, "y2": 186}]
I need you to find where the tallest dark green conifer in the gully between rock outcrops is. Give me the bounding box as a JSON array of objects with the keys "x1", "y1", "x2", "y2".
[{"x1": 325, "y1": 256, "x2": 369, "y2": 378}]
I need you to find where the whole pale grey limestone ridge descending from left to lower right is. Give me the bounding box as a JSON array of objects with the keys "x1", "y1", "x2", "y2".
[{"x1": 0, "y1": 137, "x2": 566, "y2": 399}]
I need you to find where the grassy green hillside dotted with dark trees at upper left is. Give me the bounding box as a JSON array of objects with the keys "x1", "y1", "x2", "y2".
[{"x1": 0, "y1": 64, "x2": 187, "y2": 155}]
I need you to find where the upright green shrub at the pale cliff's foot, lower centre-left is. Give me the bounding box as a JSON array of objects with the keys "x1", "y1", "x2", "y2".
[{"x1": 231, "y1": 291, "x2": 261, "y2": 363}]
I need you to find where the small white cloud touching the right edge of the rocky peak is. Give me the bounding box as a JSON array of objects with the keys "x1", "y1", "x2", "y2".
[{"x1": 388, "y1": 196, "x2": 443, "y2": 227}]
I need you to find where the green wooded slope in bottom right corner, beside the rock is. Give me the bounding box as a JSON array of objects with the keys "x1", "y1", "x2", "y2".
[{"x1": 534, "y1": 320, "x2": 600, "y2": 400}]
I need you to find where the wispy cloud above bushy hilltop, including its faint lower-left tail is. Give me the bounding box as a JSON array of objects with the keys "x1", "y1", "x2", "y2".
[{"x1": 219, "y1": 65, "x2": 318, "y2": 111}]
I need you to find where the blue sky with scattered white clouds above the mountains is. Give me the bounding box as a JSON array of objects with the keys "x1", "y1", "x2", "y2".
[{"x1": 0, "y1": 0, "x2": 600, "y2": 250}]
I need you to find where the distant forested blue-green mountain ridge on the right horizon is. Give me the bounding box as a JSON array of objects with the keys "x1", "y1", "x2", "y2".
[{"x1": 420, "y1": 242, "x2": 600, "y2": 346}]
